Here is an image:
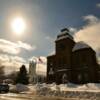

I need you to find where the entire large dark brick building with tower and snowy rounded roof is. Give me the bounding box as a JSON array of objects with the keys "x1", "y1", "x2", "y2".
[{"x1": 47, "y1": 28, "x2": 98, "y2": 84}]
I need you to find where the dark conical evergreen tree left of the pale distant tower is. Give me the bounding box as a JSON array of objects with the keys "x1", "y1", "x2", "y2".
[{"x1": 16, "y1": 65, "x2": 29, "y2": 85}]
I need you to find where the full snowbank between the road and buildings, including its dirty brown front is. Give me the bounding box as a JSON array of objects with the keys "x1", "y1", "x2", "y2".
[{"x1": 10, "y1": 83, "x2": 100, "y2": 100}]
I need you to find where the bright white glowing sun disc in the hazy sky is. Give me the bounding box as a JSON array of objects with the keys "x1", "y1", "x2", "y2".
[{"x1": 11, "y1": 17, "x2": 26, "y2": 35}]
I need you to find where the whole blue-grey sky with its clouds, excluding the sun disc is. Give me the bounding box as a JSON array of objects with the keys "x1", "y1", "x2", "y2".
[{"x1": 0, "y1": 0, "x2": 100, "y2": 75}]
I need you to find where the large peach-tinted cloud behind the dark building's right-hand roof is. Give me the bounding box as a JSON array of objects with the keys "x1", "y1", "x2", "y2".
[{"x1": 74, "y1": 15, "x2": 100, "y2": 63}]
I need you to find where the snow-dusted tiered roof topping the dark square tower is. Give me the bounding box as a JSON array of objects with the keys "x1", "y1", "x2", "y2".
[{"x1": 56, "y1": 28, "x2": 73, "y2": 41}]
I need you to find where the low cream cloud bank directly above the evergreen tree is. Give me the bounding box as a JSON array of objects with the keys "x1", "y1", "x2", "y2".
[{"x1": 0, "y1": 54, "x2": 27, "y2": 74}]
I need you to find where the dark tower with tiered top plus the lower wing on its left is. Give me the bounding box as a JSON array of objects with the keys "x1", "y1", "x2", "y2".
[{"x1": 47, "y1": 28, "x2": 75, "y2": 84}]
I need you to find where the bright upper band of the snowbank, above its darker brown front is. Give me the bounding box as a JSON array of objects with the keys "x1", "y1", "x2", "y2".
[{"x1": 10, "y1": 83, "x2": 100, "y2": 92}]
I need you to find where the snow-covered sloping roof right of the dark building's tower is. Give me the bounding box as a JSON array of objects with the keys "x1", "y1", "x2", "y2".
[{"x1": 72, "y1": 41, "x2": 91, "y2": 52}]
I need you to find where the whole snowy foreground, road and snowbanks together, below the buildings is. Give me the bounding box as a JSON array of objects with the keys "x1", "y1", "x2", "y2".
[{"x1": 0, "y1": 83, "x2": 100, "y2": 100}]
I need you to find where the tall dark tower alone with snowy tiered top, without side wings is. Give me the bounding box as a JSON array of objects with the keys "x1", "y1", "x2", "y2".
[{"x1": 55, "y1": 28, "x2": 75, "y2": 84}]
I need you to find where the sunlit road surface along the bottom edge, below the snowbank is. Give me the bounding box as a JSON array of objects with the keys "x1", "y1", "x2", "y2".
[{"x1": 0, "y1": 93, "x2": 77, "y2": 100}]
